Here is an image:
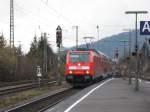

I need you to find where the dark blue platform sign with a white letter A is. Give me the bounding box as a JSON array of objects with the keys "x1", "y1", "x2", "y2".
[{"x1": 140, "y1": 21, "x2": 150, "y2": 35}]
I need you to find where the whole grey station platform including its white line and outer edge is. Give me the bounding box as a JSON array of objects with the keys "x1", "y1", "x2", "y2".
[{"x1": 47, "y1": 78, "x2": 150, "y2": 112}]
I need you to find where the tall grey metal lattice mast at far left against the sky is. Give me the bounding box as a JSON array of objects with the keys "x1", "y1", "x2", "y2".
[{"x1": 9, "y1": 0, "x2": 14, "y2": 55}]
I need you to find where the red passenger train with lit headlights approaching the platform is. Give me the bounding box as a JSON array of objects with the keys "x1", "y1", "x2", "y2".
[{"x1": 65, "y1": 49, "x2": 112, "y2": 86}]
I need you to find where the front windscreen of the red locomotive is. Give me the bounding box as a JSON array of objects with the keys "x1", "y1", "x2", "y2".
[{"x1": 70, "y1": 53, "x2": 90, "y2": 62}]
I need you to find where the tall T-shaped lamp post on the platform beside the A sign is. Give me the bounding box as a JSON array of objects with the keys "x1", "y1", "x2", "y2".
[{"x1": 125, "y1": 11, "x2": 148, "y2": 91}]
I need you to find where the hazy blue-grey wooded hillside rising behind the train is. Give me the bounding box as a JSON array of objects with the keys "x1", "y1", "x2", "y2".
[{"x1": 73, "y1": 31, "x2": 147, "y2": 58}]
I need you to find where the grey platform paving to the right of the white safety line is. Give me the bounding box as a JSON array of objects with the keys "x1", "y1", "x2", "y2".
[{"x1": 70, "y1": 79, "x2": 150, "y2": 112}]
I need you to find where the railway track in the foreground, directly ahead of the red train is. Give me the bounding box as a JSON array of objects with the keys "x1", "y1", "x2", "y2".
[{"x1": 3, "y1": 87, "x2": 80, "y2": 112}]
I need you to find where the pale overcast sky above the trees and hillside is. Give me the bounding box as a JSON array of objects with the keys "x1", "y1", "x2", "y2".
[{"x1": 0, "y1": 0, "x2": 150, "y2": 52}]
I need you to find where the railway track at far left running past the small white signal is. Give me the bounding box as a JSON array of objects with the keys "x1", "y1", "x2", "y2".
[{"x1": 0, "y1": 81, "x2": 56, "y2": 96}]
